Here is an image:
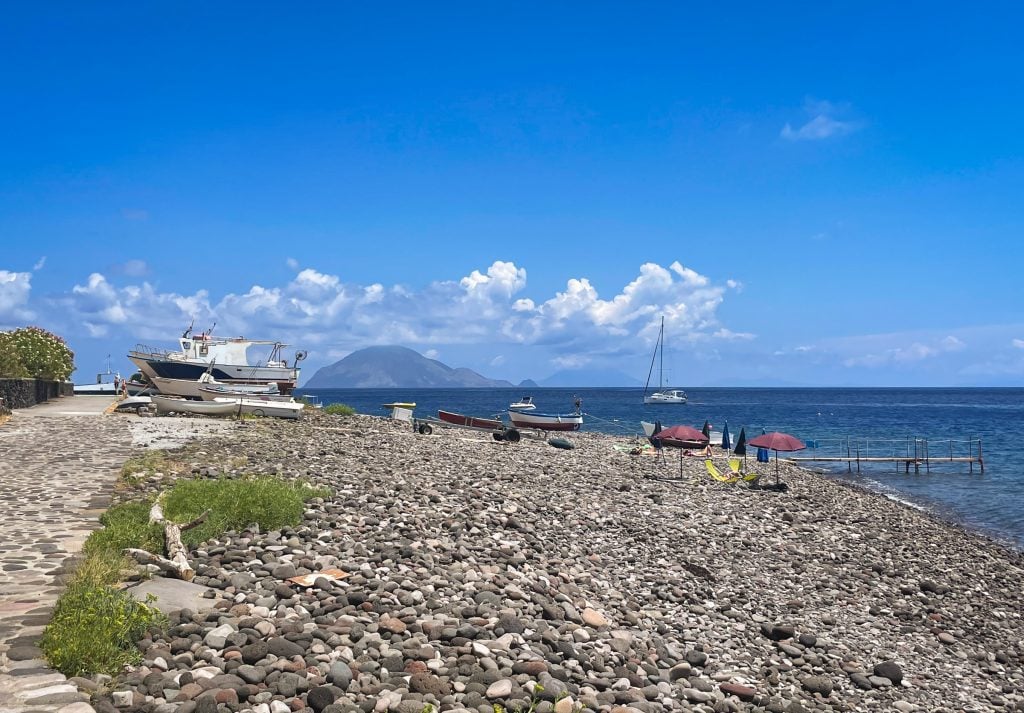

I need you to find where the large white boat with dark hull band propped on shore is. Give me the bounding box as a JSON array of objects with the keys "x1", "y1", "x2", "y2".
[{"x1": 128, "y1": 327, "x2": 306, "y2": 393}]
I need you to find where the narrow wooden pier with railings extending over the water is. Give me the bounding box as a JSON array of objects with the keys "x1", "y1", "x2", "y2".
[{"x1": 786, "y1": 437, "x2": 985, "y2": 473}]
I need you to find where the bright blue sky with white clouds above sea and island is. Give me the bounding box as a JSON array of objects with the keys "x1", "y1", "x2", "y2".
[{"x1": 0, "y1": 3, "x2": 1024, "y2": 387}]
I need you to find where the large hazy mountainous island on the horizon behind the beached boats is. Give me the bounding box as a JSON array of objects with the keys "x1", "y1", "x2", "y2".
[{"x1": 303, "y1": 345, "x2": 515, "y2": 388}]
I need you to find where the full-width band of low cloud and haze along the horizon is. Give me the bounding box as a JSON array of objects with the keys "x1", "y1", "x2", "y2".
[{"x1": 0, "y1": 258, "x2": 1024, "y2": 384}]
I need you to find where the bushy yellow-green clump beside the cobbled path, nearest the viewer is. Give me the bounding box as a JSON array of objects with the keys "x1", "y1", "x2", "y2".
[{"x1": 40, "y1": 550, "x2": 166, "y2": 677}]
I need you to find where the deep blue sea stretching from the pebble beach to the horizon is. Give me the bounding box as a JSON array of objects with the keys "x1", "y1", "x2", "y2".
[{"x1": 300, "y1": 388, "x2": 1024, "y2": 548}]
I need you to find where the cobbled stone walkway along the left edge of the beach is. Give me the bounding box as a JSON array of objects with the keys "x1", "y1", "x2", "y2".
[{"x1": 0, "y1": 396, "x2": 125, "y2": 713}]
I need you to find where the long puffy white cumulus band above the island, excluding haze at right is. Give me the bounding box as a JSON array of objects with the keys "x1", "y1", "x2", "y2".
[{"x1": 44, "y1": 260, "x2": 741, "y2": 366}]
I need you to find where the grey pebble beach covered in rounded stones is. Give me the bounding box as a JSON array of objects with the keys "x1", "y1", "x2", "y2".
[{"x1": 95, "y1": 414, "x2": 1024, "y2": 713}]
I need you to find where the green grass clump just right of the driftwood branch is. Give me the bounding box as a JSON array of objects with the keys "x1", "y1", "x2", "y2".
[{"x1": 164, "y1": 475, "x2": 330, "y2": 546}]
